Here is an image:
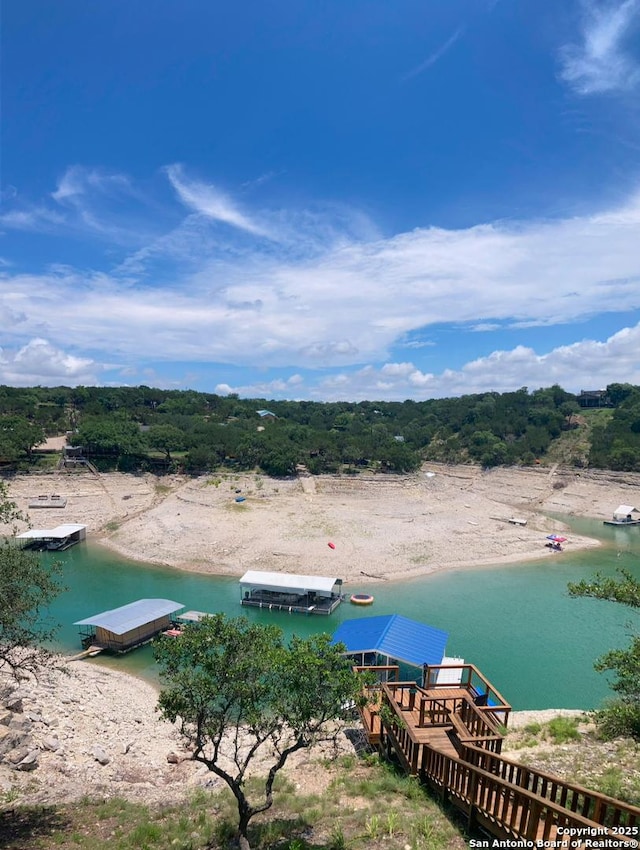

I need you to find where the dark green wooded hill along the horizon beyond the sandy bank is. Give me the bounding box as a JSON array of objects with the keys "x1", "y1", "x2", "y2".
[{"x1": 0, "y1": 384, "x2": 640, "y2": 476}]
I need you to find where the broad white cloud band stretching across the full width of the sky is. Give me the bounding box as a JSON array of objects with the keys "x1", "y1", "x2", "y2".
[{"x1": 0, "y1": 188, "x2": 640, "y2": 367}]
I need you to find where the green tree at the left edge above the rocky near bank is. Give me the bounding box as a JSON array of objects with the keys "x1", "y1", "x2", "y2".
[{"x1": 0, "y1": 482, "x2": 62, "y2": 677}]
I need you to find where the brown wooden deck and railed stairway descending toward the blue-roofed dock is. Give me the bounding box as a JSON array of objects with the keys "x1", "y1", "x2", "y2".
[{"x1": 361, "y1": 665, "x2": 640, "y2": 850}]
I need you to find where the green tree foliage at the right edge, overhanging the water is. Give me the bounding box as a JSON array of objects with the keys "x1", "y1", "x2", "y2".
[{"x1": 569, "y1": 570, "x2": 640, "y2": 738}]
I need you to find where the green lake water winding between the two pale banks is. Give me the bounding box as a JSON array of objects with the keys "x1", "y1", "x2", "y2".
[{"x1": 43, "y1": 518, "x2": 640, "y2": 709}]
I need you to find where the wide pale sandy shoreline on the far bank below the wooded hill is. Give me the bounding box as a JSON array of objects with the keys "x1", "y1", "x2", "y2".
[{"x1": 5, "y1": 464, "x2": 640, "y2": 584}]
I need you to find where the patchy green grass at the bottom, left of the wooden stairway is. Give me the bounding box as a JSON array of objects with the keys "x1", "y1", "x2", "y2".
[{"x1": 0, "y1": 760, "x2": 466, "y2": 850}]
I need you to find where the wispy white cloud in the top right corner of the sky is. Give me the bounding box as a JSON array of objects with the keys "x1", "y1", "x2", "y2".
[{"x1": 560, "y1": 0, "x2": 640, "y2": 95}]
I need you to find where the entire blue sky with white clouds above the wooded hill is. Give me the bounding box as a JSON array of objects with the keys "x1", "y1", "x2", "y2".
[{"x1": 0, "y1": 0, "x2": 640, "y2": 401}]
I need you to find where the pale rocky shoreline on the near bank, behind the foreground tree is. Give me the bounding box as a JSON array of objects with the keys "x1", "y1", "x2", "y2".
[{"x1": 0, "y1": 659, "x2": 584, "y2": 805}]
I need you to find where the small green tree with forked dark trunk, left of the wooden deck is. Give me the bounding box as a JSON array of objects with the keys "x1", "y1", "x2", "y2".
[{"x1": 155, "y1": 614, "x2": 362, "y2": 850}]
